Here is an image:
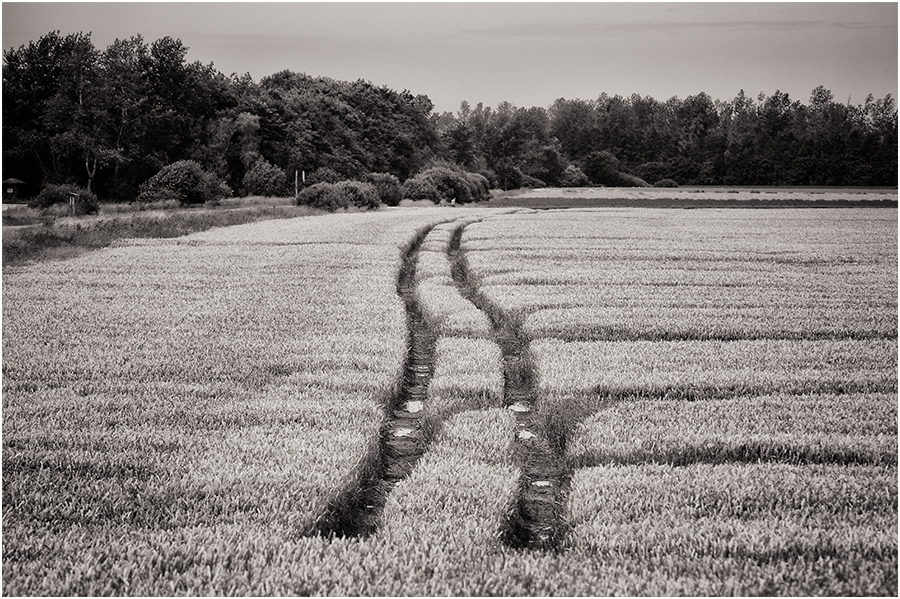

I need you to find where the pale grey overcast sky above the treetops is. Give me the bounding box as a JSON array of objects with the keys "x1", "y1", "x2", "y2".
[{"x1": 3, "y1": 2, "x2": 897, "y2": 111}]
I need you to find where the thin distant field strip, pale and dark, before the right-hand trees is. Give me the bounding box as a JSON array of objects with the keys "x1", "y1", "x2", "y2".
[{"x1": 491, "y1": 187, "x2": 897, "y2": 209}]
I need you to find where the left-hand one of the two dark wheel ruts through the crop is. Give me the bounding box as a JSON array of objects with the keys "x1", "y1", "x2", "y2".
[{"x1": 314, "y1": 225, "x2": 437, "y2": 537}]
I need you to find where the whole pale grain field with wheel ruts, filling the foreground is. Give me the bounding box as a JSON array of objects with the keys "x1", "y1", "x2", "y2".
[{"x1": 2, "y1": 204, "x2": 898, "y2": 596}]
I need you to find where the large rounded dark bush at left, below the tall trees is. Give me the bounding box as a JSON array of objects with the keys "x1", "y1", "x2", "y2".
[{"x1": 137, "y1": 160, "x2": 231, "y2": 205}]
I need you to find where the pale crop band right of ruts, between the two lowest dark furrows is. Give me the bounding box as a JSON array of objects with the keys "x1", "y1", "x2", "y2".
[{"x1": 560, "y1": 394, "x2": 897, "y2": 469}]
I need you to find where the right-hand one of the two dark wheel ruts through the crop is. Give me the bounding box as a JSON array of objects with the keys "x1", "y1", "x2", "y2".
[{"x1": 447, "y1": 225, "x2": 571, "y2": 550}]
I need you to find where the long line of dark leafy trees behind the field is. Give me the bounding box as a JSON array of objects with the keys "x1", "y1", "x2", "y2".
[{"x1": 2, "y1": 32, "x2": 897, "y2": 201}]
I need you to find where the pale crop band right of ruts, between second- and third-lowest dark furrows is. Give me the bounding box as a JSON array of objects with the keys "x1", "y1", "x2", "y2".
[{"x1": 531, "y1": 339, "x2": 897, "y2": 400}]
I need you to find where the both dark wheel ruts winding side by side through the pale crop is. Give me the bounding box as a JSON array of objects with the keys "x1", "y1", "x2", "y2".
[{"x1": 314, "y1": 218, "x2": 570, "y2": 550}]
